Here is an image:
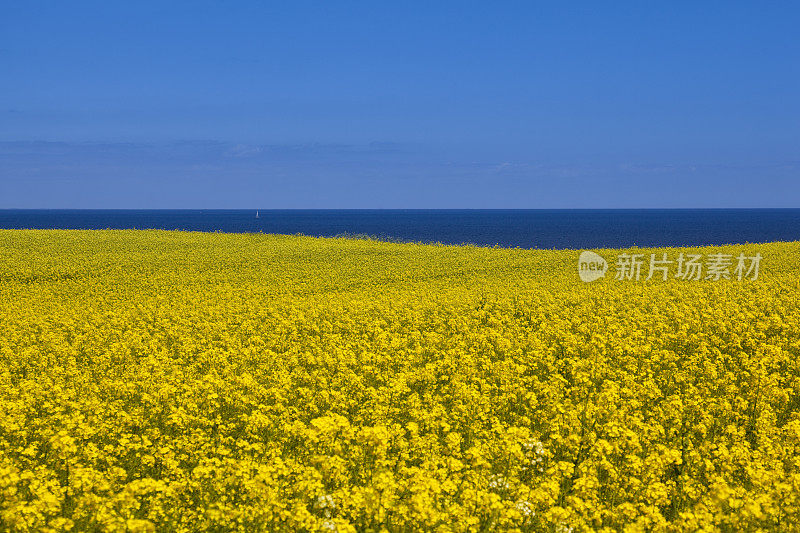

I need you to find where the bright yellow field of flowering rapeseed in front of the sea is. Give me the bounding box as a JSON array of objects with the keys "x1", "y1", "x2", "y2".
[{"x1": 0, "y1": 230, "x2": 800, "y2": 533}]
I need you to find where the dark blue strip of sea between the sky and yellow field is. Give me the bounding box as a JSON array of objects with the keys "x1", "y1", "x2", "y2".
[{"x1": 0, "y1": 209, "x2": 800, "y2": 249}]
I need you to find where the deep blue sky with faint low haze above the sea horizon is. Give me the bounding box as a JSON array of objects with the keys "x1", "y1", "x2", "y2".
[{"x1": 0, "y1": 0, "x2": 800, "y2": 208}]
